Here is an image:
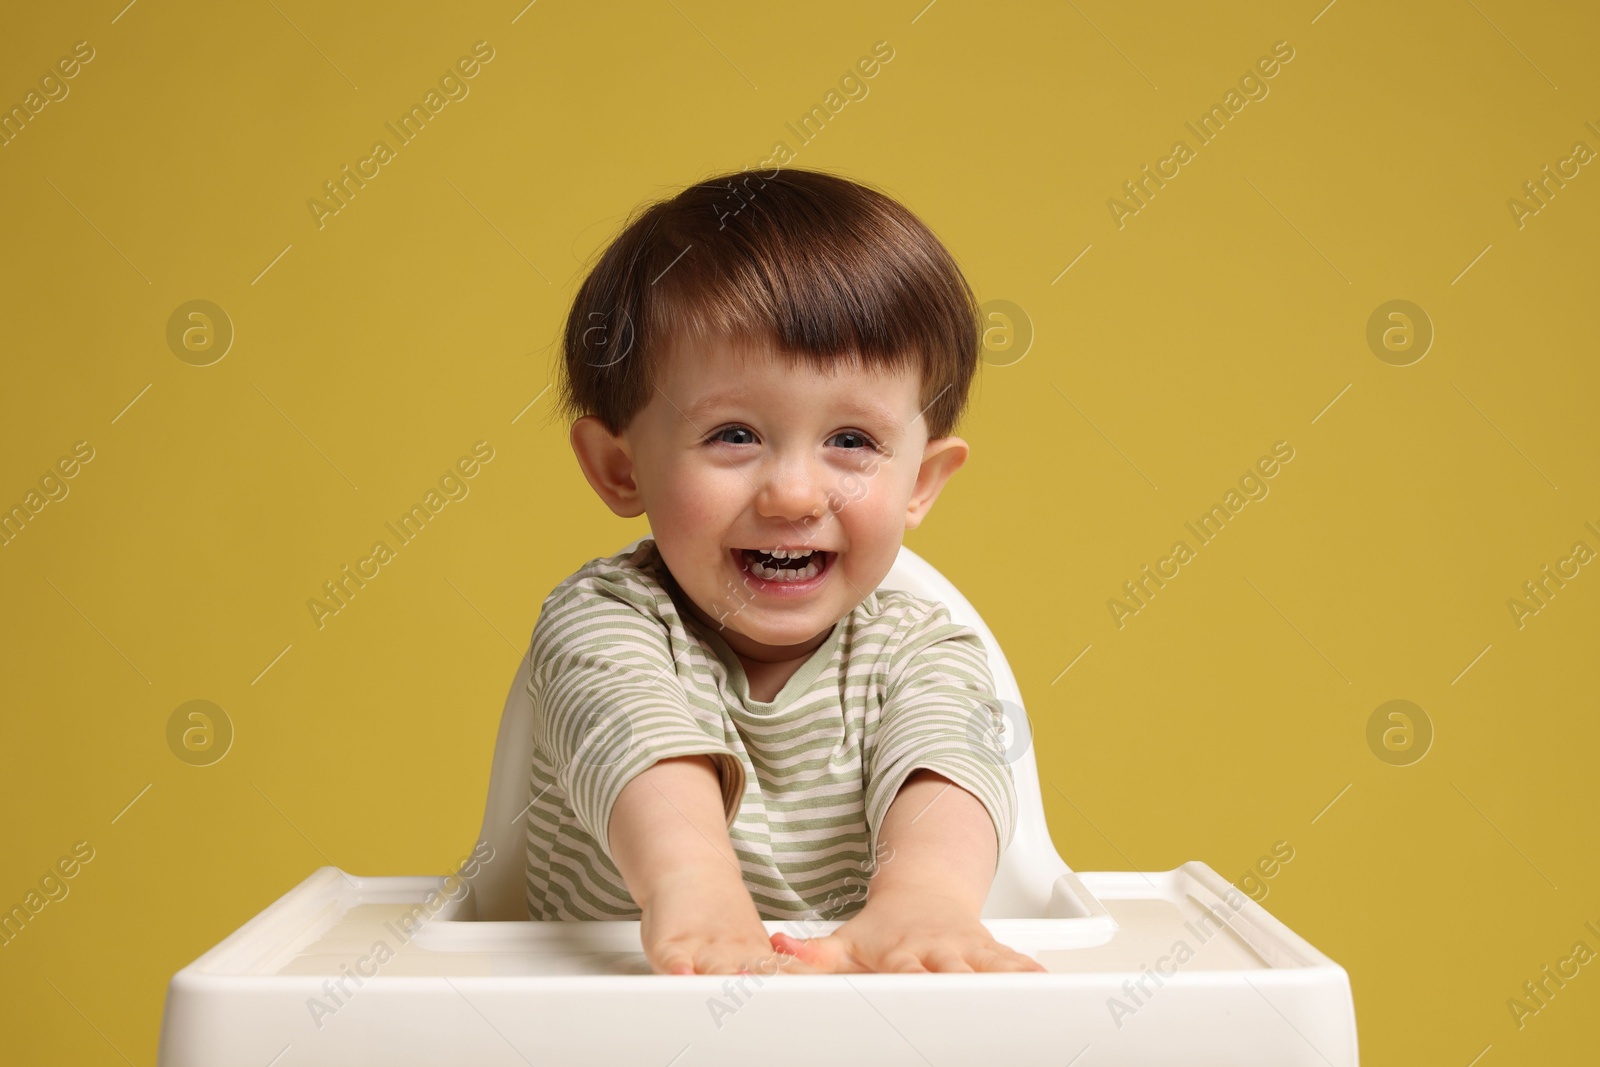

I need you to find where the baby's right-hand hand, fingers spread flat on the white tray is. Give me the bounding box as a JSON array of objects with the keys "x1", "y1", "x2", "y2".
[{"x1": 771, "y1": 891, "x2": 1045, "y2": 973}]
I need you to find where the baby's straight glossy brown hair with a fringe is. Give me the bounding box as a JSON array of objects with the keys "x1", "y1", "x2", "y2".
[{"x1": 552, "y1": 168, "x2": 981, "y2": 440}]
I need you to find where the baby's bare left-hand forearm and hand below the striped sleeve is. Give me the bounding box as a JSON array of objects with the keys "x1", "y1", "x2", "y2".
[{"x1": 608, "y1": 755, "x2": 819, "y2": 974}]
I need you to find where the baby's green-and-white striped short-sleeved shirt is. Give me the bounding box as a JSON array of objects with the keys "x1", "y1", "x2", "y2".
[{"x1": 526, "y1": 539, "x2": 1016, "y2": 920}]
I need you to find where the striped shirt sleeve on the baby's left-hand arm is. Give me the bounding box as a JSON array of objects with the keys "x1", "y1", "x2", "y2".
[{"x1": 528, "y1": 577, "x2": 744, "y2": 862}]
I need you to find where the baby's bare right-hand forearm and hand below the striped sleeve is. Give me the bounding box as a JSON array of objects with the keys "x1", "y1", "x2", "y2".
[{"x1": 771, "y1": 768, "x2": 1045, "y2": 971}]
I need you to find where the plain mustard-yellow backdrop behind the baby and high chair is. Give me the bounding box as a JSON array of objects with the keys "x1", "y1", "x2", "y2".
[{"x1": 0, "y1": 0, "x2": 1600, "y2": 1067}]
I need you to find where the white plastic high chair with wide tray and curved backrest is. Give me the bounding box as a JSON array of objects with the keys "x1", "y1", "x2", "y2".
[{"x1": 157, "y1": 534, "x2": 1358, "y2": 1067}]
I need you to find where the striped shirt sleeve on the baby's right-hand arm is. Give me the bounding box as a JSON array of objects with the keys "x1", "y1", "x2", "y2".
[{"x1": 867, "y1": 603, "x2": 1016, "y2": 869}]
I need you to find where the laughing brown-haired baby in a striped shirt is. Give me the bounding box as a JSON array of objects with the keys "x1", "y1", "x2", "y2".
[{"x1": 528, "y1": 170, "x2": 1045, "y2": 974}]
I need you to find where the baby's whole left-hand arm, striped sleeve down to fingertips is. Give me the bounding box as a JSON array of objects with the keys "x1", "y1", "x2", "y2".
[{"x1": 528, "y1": 568, "x2": 803, "y2": 974}]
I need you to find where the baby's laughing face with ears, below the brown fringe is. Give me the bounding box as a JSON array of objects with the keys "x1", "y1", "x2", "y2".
[{"x1": 590, "y1": 334, "x2": 968, "y2": 662}]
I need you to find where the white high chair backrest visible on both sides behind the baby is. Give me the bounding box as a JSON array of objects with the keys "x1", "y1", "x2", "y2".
[{"x1": 470, "y1": 534, "x2": 1069, "y2": 921}]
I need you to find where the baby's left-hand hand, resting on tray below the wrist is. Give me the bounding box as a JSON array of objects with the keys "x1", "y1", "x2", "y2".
[{"x1": 640, "y1": 878, "x2": 819, "y2": 976}]
